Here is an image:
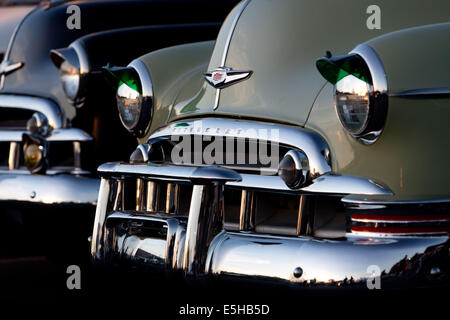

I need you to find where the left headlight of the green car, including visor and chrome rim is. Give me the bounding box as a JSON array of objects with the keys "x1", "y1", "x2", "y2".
[{"x1": 103, "y1": 60, "x2": 153, "y2": 137}]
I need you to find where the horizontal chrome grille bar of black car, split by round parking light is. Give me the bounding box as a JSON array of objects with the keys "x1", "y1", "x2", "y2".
[{"x1": 0, "y1": 128, "x2": 94, "y2": 142}]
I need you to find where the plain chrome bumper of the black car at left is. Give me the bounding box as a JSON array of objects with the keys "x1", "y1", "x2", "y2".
[{"x1": 0, "y1": 174, "x2": 100, "y2": 205}]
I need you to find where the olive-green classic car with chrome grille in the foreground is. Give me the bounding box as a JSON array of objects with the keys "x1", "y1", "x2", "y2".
[{"x1": 91, "y1": 0, "x2": 450, "y2": 290}]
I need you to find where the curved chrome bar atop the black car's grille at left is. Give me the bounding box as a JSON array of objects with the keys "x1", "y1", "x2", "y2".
[{"x1": 0, "y1": 94, "x2": 65, "y2": 129}]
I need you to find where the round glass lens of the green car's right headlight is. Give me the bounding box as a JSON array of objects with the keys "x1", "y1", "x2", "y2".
[{"x1": 335, "y1": 75, "x2": 372, "y2": 135}]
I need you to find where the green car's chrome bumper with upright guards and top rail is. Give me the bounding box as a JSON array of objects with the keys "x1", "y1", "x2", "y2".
[{"x1": 91, "y1": 164, "x2": 450, "y2": 289}]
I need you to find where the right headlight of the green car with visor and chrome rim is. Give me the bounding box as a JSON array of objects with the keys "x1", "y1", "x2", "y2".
[{"x1": 316, "y1": 45, "x2": 388, "y2": 144}]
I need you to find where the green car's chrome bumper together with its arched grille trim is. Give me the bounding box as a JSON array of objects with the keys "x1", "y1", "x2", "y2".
[{"x1": 91, "y1": 119, "x2": 450, "y2": 288}]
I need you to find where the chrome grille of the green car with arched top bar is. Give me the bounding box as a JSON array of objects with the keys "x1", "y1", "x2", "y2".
[{"x1": 91, "y1": 119, "x2": 391, "y2": 274}]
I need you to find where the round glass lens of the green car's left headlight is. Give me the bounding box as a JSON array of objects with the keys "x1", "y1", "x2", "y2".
[{"x1": 117, "y1": 83, "x2": 142, "y2": 130}]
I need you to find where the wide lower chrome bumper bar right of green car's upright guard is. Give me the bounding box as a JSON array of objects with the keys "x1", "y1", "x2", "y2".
[{"x1": 206, "y1": 232, "x2": 450, "y2": 288}]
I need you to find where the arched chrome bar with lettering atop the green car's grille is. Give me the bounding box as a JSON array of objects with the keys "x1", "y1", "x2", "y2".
[{"x1": 149, "y1": 118, "x2": 331, "y2": 177}]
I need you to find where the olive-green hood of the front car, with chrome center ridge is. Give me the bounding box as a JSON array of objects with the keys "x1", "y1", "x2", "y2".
[{"x1": 170, "y1": 0, "x2": 450, "y2": 125}]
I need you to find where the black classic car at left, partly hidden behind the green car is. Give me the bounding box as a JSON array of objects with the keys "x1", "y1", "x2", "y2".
[{"x1": 0, "y1": 0, "x2": 237, "y2": 254}]
